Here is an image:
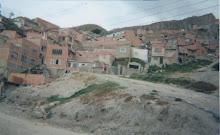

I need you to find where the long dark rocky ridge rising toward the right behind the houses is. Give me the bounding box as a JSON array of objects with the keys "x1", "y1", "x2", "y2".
[{"x1": 109, "y1": 13, "x2": 216, "y2": 33}]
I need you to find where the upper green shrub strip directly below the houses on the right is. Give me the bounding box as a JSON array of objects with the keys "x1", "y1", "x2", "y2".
[{"x1": 148, "y1": 59, "x2": 212, "y2": 73}]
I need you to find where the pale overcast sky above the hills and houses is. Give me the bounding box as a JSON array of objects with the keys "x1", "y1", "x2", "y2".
[{"x1": 0, "y1": 0, "x2": 219, "y2": 30}]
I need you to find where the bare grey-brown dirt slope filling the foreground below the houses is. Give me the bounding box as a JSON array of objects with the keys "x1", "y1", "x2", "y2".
[{"x1": 0, "y1": 73, "x2": 219, "y2": 135}]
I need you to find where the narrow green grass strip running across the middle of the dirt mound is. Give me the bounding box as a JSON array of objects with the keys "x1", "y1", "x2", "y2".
[{"x1": 47, "y1": 81, "x2": 121, "y2": 103}]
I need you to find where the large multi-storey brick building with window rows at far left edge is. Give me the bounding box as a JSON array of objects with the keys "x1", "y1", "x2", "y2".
[{"x1": 0, "y1": 32, "x2": 40, "y2": 77}]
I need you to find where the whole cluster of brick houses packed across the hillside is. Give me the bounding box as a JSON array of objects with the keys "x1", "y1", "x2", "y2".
[{"x1": 0, "y1": 17, "x2": 219, "y2": 85}]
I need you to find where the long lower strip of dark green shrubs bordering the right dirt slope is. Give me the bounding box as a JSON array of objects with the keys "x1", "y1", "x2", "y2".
[{"x1": 130, "y1": 74, "x2": 217, "y2": 94}]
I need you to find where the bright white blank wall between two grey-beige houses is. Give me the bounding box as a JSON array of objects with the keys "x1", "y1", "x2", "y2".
[{"x1": 131, "y1": 47, "x2": 148, "y2": 63}]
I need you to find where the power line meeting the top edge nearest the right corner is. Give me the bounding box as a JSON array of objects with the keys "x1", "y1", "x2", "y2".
[{"x1": 104, "y1": 0, "x2": 208, "y2": 27}]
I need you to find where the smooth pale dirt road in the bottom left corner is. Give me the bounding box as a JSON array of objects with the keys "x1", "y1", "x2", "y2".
[{"x1": 0, "y1": 112, "x2": 91, "y2": 135}]
